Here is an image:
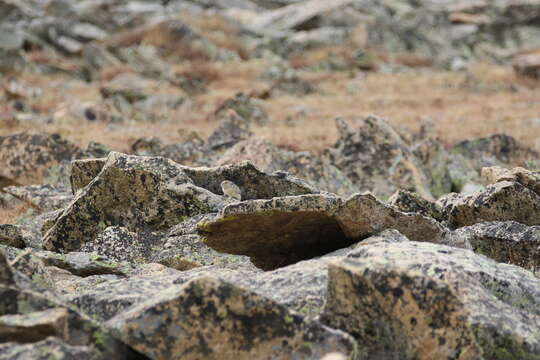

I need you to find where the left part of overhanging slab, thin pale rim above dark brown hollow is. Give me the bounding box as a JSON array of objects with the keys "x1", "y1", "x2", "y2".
[{"x1": 199, "y1": 195, "x2": 351, "y2": 269}]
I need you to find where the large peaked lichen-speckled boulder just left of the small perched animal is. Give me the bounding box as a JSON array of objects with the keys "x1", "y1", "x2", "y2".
[{"x1": 43, "y1": 152, "x2": 227, "y2": 252}]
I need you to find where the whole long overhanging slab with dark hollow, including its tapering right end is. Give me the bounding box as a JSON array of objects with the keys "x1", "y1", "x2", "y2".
[{"x1": 198, "y1": 194, "x2": 448, "y2": 270}]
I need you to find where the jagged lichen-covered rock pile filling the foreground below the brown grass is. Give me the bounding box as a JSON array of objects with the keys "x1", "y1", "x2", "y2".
[{"x1": 0, "y1": 112, "x2": 540, "y2": 360}]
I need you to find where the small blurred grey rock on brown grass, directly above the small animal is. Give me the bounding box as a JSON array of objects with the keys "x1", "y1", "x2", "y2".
[{"x1": 214, "y1": 93, "x2": 269, "y2": 125}]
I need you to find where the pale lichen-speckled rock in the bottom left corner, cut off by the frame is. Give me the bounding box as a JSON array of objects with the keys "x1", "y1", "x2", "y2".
[{"x1": 0, "y1": 337, "x2": 103, "y2": 360}]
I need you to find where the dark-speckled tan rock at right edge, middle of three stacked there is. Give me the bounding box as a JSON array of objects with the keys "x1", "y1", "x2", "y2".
[{"x1": 443, "y1": 181, "x2": 540, "y2": 227}]
